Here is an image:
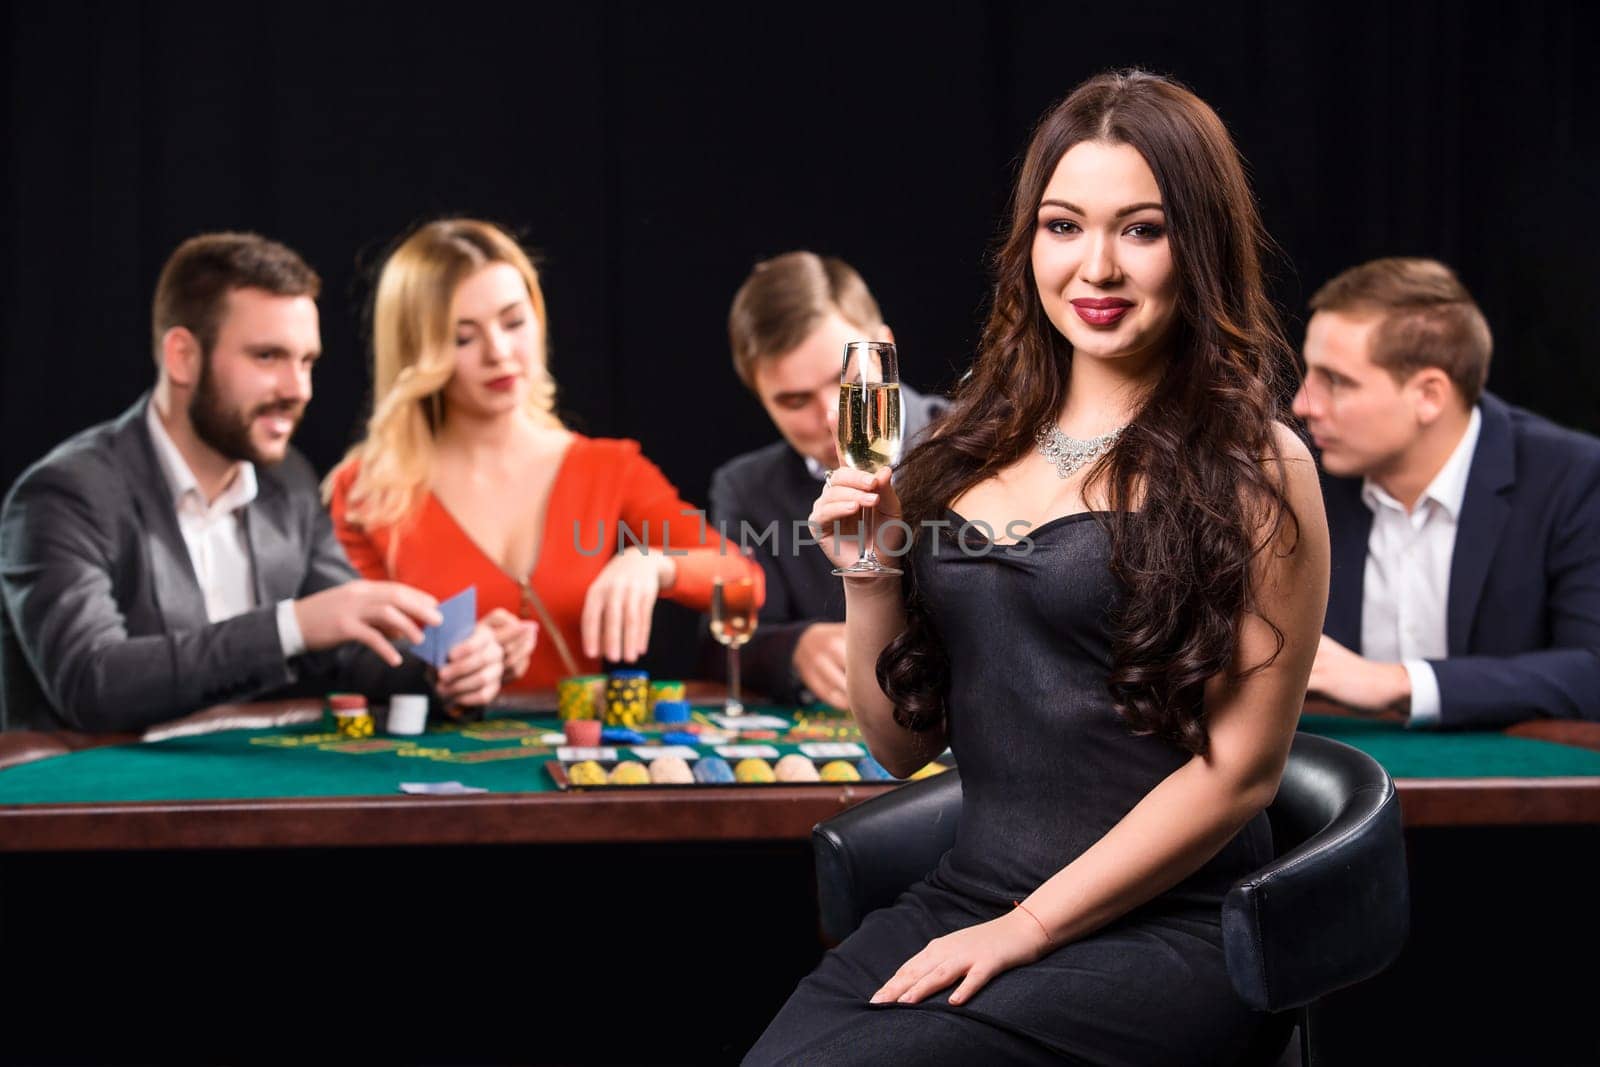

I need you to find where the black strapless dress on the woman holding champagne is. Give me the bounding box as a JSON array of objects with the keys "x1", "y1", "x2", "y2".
[{"x1": 746, "y1": 512, "x2": 1272, "y2": 1067}]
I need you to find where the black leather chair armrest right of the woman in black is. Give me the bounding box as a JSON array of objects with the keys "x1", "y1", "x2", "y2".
[{"x1": 1222, "y1": 751, "x2": 1411, "y2": 1011}]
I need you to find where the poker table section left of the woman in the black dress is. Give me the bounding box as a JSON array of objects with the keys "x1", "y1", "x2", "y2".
[{"x1": 0, "y1": 702, "x2": 915, "y2": 851}]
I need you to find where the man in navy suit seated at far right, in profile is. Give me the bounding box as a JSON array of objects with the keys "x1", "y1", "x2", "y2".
[{"x1": 1294, "y1": 259, "x2": 1600, "y2": 728}]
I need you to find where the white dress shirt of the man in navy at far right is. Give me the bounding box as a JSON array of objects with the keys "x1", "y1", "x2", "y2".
[{"x1": 1362, "y1": 408, "x2": 1483, "y2": 726}]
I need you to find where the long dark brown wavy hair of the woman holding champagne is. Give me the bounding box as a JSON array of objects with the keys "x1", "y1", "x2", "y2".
[{"x1": 877, "y1": 70, "x2": 1298, "y2": 753}]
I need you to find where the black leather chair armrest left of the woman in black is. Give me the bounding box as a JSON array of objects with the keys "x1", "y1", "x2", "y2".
[{"x1": 811, "y1": 769, "x2": 962, "y2": 942}]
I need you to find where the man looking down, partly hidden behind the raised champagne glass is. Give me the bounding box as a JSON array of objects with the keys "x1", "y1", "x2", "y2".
[{"x1": 707, "y1": 251, "x2": 944, "y2": 707}]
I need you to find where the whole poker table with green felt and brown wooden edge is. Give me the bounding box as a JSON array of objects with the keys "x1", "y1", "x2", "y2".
[{"x1": 0, "y1": 700, "x2": 1600, "y2": 851}]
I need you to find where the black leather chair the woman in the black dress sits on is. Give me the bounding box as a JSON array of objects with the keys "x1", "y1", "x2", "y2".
[{"x1": 811, "y1": 734, "x2": 1411, "y2": 1067}]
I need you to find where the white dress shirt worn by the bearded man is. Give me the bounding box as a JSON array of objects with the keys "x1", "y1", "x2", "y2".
[{"x1": 144, "y1": 402, "x2": 306, "y2": 659}]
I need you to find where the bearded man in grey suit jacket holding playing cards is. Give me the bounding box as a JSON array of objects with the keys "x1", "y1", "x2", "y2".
[{"x1": 0, "y1": 234, "x2": 502, "y2": 731}]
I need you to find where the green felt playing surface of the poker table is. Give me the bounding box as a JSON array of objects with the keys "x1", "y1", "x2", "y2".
[{"x1": 0, "y1": 707, "x2": 1600, "y2": 805}]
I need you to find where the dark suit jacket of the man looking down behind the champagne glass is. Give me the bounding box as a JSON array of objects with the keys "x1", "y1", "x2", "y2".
[{"x1": 701, "y1": 382, "x2": 946, "y2": 704}]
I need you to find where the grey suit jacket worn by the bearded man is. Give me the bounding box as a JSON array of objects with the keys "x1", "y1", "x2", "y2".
[{"x1": 0, "y1": 395, "x2": 427, "y2": 731}]
